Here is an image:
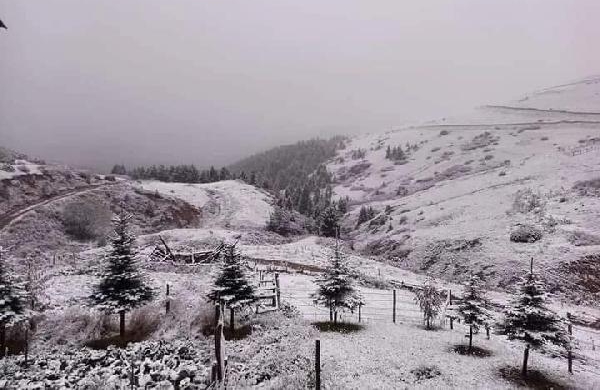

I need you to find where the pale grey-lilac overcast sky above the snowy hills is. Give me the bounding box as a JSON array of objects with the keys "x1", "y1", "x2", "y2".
[{"x1": 0, "y1": 0, "x2": 600, "y2": 167}]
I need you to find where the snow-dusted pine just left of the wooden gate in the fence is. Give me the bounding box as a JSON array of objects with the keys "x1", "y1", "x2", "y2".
[{"x1": 208, "y1": 245, "x2": 257, "y2": 331}]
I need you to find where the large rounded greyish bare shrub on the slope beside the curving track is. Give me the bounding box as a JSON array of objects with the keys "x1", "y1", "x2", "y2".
[{"x1": 62, "y1": 201, "x2": 111, "y2": 240}]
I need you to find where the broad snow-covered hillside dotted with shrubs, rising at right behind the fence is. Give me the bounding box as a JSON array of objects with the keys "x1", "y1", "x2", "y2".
[{"x1": 328, "y1": 79, "x2": 600, "y2": 298}]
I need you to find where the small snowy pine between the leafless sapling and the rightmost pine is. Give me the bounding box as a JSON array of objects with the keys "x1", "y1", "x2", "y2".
[{"x1": 457, "y1": 274, "x2": 491, "y2": 352}]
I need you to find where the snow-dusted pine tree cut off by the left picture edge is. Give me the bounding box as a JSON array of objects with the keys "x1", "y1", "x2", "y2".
[{"x1": 0, "y1": 246, "x2": 26, "y2": 356}]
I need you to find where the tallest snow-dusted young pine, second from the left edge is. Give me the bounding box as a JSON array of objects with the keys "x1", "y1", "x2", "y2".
[{"x1": 90, "y1": 213, "x2": 154, "y2": 337}]
